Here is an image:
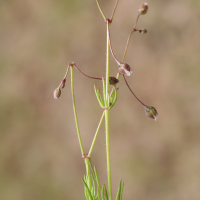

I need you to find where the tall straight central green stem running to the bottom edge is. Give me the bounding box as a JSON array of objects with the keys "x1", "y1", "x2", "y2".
[{"x1": 105, "y1": 20, "x2": 112, "y2": 200}]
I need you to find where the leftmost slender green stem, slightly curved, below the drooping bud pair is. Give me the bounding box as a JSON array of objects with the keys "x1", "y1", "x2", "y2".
[{"x1": 71, "y1": 66, "x2": 85, "y2": 157}]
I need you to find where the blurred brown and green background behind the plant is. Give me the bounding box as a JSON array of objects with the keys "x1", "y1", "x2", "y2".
[{"x1": 0, "y1": 0, "x2": 200, "y2": 200}]
